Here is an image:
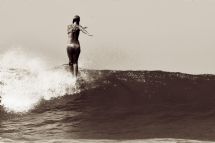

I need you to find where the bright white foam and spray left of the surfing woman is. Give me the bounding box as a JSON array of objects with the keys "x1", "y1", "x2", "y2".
[{"x1": 0, "y1": 50, "x2": 84, "y2": 112}]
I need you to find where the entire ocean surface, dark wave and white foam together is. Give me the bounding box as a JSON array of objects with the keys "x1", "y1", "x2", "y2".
[{"x1": 0, "y1": 51, "x2": 215, "y2": 143}]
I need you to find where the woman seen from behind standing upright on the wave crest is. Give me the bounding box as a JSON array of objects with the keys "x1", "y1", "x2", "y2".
[{"x1": 67, "y1": 15, "x2": 92, "y2": 77}]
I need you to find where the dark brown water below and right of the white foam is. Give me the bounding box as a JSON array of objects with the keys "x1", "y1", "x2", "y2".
[{"x1": 0, "y1": 70, "x2": 215, "y2": 142}]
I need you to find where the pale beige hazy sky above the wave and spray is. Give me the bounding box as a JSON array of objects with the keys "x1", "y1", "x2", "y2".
[{"x1": 0, "y1": 0, "x2": 215, "y2": 73}]
